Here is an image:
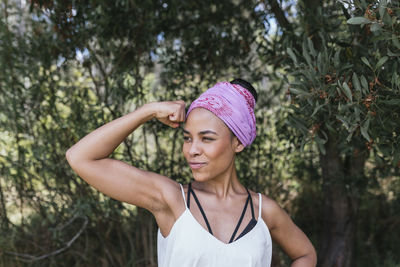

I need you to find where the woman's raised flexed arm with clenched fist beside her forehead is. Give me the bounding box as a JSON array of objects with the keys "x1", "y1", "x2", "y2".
[{"x1": 66, "y1": 101, "x2": 185, "y2": 212}]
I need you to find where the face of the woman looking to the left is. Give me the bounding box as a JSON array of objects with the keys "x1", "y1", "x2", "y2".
[{"x1": 183, "y1": 108, "x2": 244, "y2": 182}]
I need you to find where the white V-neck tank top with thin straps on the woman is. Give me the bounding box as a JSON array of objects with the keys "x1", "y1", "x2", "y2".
[{"x1": 157, "y1": 185, "x2": 272, "y2": 267}]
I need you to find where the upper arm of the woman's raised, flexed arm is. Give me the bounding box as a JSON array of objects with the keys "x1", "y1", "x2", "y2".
[{"x1": 66, "y1": 158, "x2": 175, "y2": 211}]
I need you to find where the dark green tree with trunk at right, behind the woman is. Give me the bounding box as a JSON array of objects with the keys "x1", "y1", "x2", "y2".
[{"x1": 260, "y1": 0, "x2": 400, "y2": 267}]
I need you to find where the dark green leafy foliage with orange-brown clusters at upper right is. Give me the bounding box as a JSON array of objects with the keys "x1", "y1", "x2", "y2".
[{"x1": 287, "y1": 1, "x2": 400, "y2": 168}]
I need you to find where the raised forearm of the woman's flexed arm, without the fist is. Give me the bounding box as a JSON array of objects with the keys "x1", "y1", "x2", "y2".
[{"x1": 67, "y1": 103, "x2": 155, "y2": 162}]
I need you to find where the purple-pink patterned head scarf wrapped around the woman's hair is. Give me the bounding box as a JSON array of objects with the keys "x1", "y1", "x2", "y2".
[{"x1": 186, "y1": 82, "x2": 256, "y2": 147}]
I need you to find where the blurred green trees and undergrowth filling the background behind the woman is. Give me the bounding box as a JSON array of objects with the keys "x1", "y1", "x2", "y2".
[{"x1": 0, "y1": 0, "x2": 400, "y2": 267}]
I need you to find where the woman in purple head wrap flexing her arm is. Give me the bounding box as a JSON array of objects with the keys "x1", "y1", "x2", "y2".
[{"x1": 66, "y1": 79, "x2": 316, "y2": 267}]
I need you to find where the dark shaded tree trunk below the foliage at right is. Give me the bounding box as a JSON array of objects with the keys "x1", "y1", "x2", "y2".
[{"x1": 318, "y1": 138, "x2": 365, "y2": 267}]
